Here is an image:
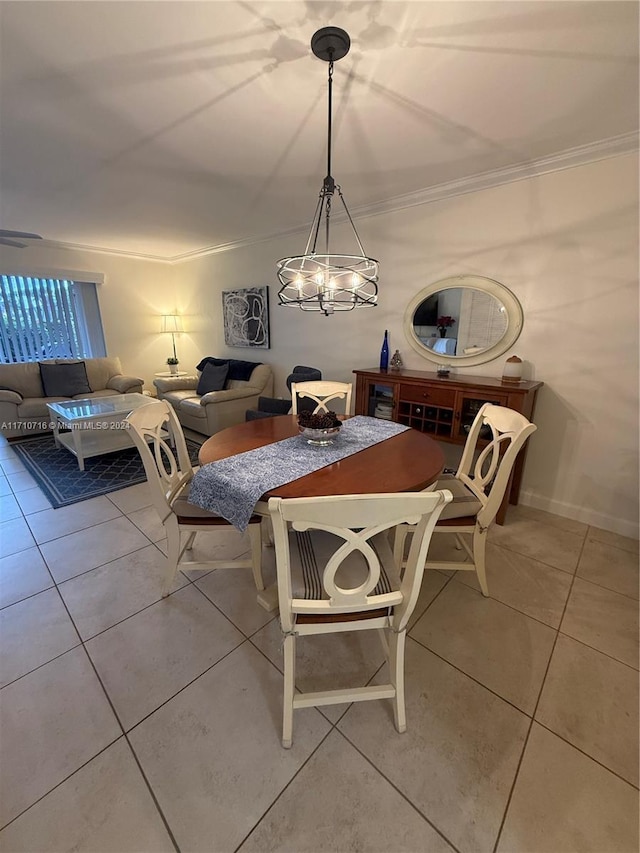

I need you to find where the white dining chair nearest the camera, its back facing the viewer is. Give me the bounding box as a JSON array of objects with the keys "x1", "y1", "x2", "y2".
[{"x1": 269, "y1": 491, "x2": 451, "y2": 747}]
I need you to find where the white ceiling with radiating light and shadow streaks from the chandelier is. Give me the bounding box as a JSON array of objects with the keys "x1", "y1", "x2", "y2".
[{"x1": 0, "y1": 0, "x2": 638, "y2": 258}]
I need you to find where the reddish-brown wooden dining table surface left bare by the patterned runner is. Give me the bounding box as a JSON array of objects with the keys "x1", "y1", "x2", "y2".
[{"x1": 198, "y1": 415, "x2": 444, "y2": 611}]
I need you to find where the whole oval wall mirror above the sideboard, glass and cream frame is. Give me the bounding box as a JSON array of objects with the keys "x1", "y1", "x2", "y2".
[{"x1": 404, "y1": 275, "x2": 523, "y2": 367}]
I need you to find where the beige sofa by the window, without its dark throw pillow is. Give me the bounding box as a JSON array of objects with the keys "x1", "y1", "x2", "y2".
[{"x1": 0, "y1": 358, "x2": 144, "y2": 438}]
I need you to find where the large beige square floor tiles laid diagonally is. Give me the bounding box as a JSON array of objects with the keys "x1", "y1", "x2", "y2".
[{"x1": 0, "y1": 443, "x2": 638, "y2": 853}]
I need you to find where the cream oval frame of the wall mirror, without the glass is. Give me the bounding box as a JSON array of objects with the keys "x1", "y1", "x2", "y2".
[{"x1": 404, "y1": 275, "x2": 524, "y2": 367}]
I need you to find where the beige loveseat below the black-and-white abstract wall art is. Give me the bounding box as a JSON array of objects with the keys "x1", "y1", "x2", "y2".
[{"x1": 153, "y1": 362, "x2": 273, "y2": 435}]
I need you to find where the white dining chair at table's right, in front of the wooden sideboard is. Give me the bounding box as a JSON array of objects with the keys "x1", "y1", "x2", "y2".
[{"x1": 394, "y1": 403, "x2": 537, "y2": 595}]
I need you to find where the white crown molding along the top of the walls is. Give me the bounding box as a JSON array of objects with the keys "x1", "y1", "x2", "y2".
[{"x1": 22, "y1": 131, "x2": 640, "y2": 264}]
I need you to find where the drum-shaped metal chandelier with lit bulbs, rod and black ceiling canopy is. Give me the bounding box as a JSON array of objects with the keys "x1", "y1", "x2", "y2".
[{"x1": 276, "y1": 27, "x2": 378, "y2": 316}]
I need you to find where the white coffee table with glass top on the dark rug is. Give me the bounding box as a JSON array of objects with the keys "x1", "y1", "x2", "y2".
[{"x1": 47, "y1": 394, "x2": 155, "y2": 471}]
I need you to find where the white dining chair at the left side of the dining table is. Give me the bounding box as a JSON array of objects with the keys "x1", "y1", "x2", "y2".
[{"x1": 126, "y1": 400, "x2": 264, "y2": 597}]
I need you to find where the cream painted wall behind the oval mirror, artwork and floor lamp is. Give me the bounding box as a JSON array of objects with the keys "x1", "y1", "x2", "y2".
[{"x1": 0, "y1": 155, "x2": 639, "y2": 536}]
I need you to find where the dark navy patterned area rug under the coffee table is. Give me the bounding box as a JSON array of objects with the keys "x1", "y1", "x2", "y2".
[{"x1": 11, "y1": 435, "x2": 200, "y2": 509}]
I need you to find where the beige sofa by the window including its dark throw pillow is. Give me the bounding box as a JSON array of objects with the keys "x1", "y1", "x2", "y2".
[{"x1": 0, "y1": 358, "x2": 144, "y2": 438}]
